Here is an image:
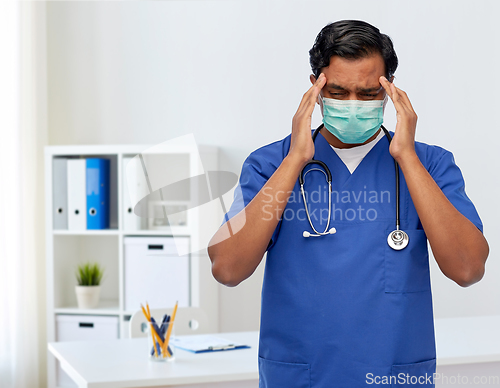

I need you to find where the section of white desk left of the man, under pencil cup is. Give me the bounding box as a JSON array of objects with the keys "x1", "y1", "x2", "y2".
[{"x1": 49, "y1": 331, "x2": 259, "y2": 388}]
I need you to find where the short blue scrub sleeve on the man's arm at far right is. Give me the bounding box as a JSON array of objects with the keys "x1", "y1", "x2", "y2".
[{"x1": 429, "y1": 147, "x2": 483, "y2": 232}]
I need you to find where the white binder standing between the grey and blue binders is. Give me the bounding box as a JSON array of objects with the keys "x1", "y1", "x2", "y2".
[{"x1": 66, "y1": 159, "x2": 87, "y2": 230}]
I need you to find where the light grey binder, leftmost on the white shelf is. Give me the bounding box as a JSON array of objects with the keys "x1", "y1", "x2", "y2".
[{"x1": 52, "y1": 158, "x2": 68, "y2": 229}]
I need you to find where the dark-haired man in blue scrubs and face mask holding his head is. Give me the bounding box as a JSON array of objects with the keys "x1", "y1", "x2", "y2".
[{"x1": 208, "y1": 20, "x2": 489, "y2": 388}]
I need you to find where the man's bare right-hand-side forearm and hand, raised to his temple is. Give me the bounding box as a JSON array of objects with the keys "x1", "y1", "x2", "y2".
[{"x1": 379, "y1": 77, "x2": 489, "y2": 287}]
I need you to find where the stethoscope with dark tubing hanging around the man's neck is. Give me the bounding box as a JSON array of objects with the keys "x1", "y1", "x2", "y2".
[{"x1": 299, "y1": 124, "x2": 410, "y2": 251}]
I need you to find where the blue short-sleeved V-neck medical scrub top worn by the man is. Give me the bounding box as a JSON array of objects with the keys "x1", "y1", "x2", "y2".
[{"x1": 221, "y1": 129, "x2": 482, "y2": 388}]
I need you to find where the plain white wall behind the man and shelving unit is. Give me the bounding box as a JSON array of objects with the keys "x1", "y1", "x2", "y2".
[{"x1": 48, "y1": 0, "x2": 500, "y2": 330}]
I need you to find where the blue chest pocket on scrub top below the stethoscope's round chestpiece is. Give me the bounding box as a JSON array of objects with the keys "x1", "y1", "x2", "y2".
[{"x1": 384, "y1": 229, "x2": 431, "y2": 293}]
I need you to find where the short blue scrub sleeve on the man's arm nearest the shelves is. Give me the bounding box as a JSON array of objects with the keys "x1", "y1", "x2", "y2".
[{"x1": 222, "y1": 149, "x2": 281, "y2": 250}]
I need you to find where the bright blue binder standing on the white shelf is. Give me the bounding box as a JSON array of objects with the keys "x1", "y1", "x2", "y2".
[{"x1": 86, "y1": 158, "x2": 109, "y2": 229}]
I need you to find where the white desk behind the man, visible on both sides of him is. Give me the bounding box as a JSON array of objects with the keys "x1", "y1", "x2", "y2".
[{"x1": 49, "y1": 316, "x2": 500, "y2": 388}]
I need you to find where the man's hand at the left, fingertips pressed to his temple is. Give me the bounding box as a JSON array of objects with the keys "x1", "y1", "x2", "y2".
[{"x1": 289, "y1": 73, "x2": 326, "y2": 165}]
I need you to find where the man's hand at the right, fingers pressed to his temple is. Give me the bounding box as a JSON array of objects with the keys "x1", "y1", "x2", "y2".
[{"x1": 379, "y1": 76, "x2": 417, "y2": 162}]
